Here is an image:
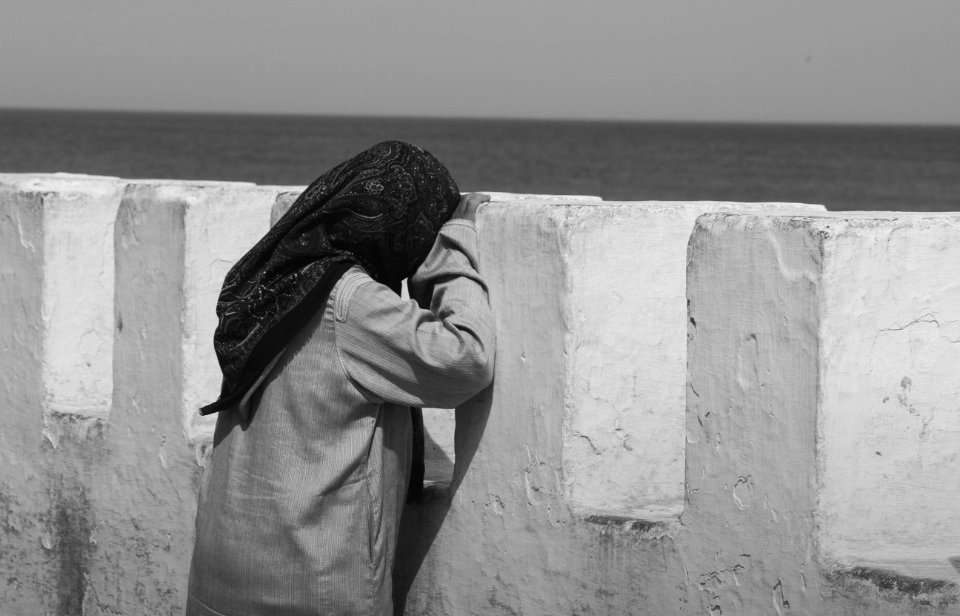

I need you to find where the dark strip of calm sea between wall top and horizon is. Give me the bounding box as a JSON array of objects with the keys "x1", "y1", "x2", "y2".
[{"x1": 0, "y1": 110, "x2": 960, "y2": 211}]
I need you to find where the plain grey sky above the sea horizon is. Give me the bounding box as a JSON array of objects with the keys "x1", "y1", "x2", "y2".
[{"x1": 0, "y1": 0, "x2": 960, "y2": 124}]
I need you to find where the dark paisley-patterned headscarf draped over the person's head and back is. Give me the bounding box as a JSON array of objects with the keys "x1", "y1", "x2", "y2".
[{"x1": 200, "y1": 141, "x2": 460, "y2": 415}]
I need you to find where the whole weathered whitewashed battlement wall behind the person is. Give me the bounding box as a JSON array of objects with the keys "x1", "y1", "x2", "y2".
[{"x1": 0, "y1": 174, "x2": 960, "y2": 615}]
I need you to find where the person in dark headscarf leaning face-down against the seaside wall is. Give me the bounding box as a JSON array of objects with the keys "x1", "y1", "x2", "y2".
[{"x1": 186, "y1": 141, "x2": 495, "y2": 616}]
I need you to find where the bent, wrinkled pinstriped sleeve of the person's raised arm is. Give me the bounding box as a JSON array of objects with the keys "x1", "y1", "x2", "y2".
[{"x1": 334, "y1": 219, "x2": 495, "y2": 408}]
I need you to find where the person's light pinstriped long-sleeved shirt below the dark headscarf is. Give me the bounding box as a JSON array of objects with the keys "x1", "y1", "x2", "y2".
[{"x1": 187, "y1": 142, "x2": 494, "y2": 616}]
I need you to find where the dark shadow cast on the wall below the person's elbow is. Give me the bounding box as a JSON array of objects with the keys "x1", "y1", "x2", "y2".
[{"x1": 393, "y1": 384, "x2": 493, "y2": 616}]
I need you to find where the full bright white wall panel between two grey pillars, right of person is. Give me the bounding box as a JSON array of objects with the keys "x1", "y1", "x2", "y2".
[{"x1": 560, "y1": 201, "x2": 823, "y2": 521}]
